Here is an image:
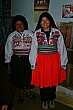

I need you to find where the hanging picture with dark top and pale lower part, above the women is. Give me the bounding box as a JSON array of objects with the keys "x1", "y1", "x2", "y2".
[{"x1": 33, "y1": 0, "x2": 50, "y2": 22}]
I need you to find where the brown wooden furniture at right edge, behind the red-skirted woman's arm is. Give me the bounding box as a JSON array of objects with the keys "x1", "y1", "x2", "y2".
[{"x1": 57, "y1": 22, "x2": 73, "y2": 89}]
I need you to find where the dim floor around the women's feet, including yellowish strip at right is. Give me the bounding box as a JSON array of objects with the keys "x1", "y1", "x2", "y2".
[{"x1": 0, "y1": 57, "x2": 73, "y2": 110}]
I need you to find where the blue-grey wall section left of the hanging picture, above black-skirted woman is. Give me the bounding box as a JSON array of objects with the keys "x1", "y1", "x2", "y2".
[{"x1": 11, "y1": 0, "x2": 35, "y2": 30}]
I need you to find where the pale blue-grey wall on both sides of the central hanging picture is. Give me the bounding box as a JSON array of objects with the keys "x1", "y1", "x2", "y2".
[{"x1": 11, "y1": 0, "x2": 73, "y2": 30}]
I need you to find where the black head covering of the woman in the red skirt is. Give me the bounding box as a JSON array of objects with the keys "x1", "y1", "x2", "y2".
[{"x1": 35, "y1": 12, "x2": 57, "y2": 30}]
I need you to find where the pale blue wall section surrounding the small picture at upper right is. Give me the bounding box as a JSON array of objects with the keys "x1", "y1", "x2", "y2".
[{"x1": 49, "y1": 0, "x2": 73, "y2": 22}]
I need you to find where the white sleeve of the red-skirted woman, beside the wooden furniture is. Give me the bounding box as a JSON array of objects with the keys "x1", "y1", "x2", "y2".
[{"x1": 58, "y1": 32, "x2": 68, "y2": 69}]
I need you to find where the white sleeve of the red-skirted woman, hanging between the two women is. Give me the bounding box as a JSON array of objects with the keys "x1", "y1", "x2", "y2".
[{"x1": 29, "y1": 31, "x2": 38, "y2": 69}]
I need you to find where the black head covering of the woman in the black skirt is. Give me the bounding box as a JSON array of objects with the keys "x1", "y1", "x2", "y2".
[{"x1": 12, "y1": 15, "x2": 28, "y2": 31}]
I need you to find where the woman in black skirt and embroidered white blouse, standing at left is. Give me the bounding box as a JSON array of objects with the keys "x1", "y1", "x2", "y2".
[{"x1": 5, "y1": 15, "x2": 34, "y2": 102}]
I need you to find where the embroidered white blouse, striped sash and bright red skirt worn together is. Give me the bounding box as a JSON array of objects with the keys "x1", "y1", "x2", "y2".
[{"x1": 31, "y1": 28, "x2": 68, "y2": 88}]
